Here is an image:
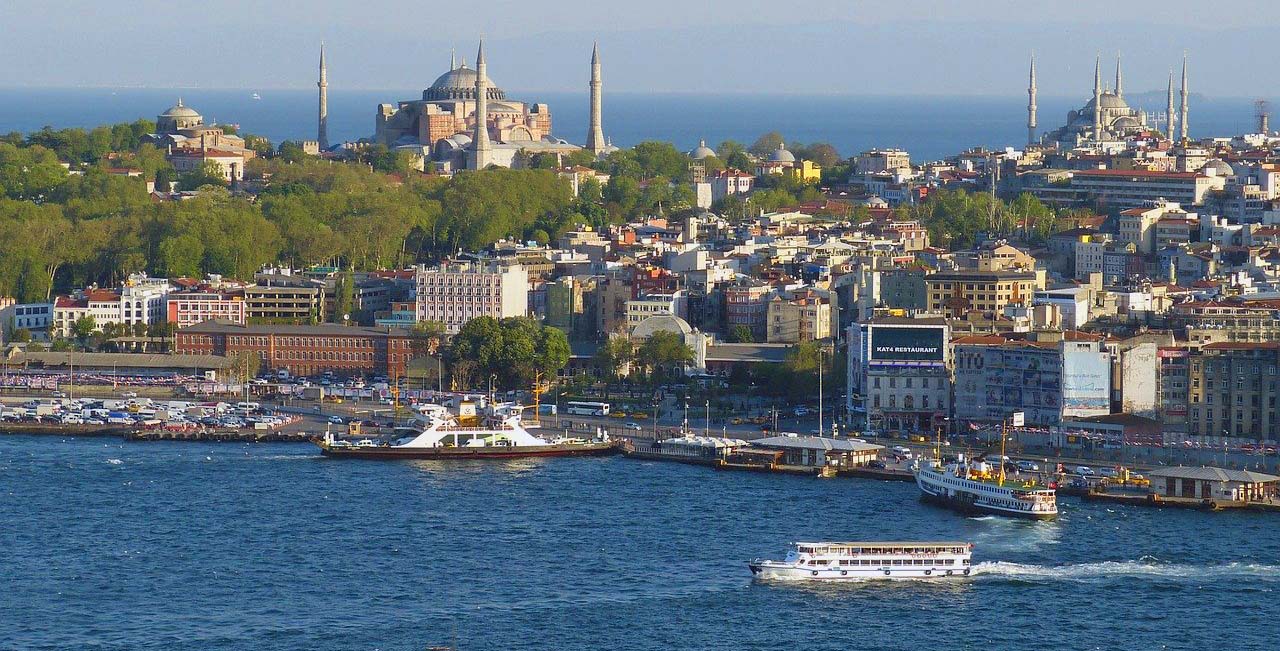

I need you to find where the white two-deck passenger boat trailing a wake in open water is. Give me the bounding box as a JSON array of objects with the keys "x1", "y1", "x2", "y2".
[{"x1": 748, "y1": 542, "x2": 973, "y2": 581}]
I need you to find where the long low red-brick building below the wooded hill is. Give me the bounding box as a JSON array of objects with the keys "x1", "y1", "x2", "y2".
[{"x1": 174, "y1": 321, "x2": 412, "y2": 377}]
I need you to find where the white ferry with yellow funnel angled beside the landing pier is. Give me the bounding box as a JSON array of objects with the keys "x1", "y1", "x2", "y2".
[{"x1": 915, "y1": 457, "x2": 1057, "y2": 519}]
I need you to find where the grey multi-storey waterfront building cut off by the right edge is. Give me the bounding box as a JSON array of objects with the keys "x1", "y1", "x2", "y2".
[{"x1": 1187, "y1": 341, "x2": 1280, "y2": 440}]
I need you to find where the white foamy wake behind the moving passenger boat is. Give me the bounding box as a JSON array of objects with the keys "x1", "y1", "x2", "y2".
[{"x1": 973, "y1": 556, "x2": 1280, "y2": 583}]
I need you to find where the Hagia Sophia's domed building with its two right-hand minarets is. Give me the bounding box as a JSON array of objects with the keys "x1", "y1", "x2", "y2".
[{"x1": 374, "y1": 37, "x2": 609, "y2": 171}]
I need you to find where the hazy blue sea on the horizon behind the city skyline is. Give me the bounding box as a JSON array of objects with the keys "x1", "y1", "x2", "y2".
[{"x1": 0, "y1": 88, "x2": 1254, "y2": 160}]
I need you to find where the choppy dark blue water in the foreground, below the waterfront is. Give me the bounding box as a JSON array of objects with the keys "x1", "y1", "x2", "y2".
[{"x1": 0, "y1": 436, "x2": 1280, "y2": 651}]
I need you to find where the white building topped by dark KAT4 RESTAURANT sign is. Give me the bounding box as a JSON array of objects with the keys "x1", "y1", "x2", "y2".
[{"x1": 846, "y1": 317, "x2": 951, "y2": 432}]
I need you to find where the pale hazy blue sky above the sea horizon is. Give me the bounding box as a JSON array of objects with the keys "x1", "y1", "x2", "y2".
[{"x1": 0, "y1": 0, "x2": 1280, "y2": 96}]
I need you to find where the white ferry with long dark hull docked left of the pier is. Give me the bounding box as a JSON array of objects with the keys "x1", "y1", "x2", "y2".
[{"x1": 316, "y1": 412, "x2": 621, "y2": 459}]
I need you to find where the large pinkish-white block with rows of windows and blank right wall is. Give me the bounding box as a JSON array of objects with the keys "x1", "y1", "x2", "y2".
[{"x1": 416, "y1": 262, "x2": 529, "y2": 335}]
